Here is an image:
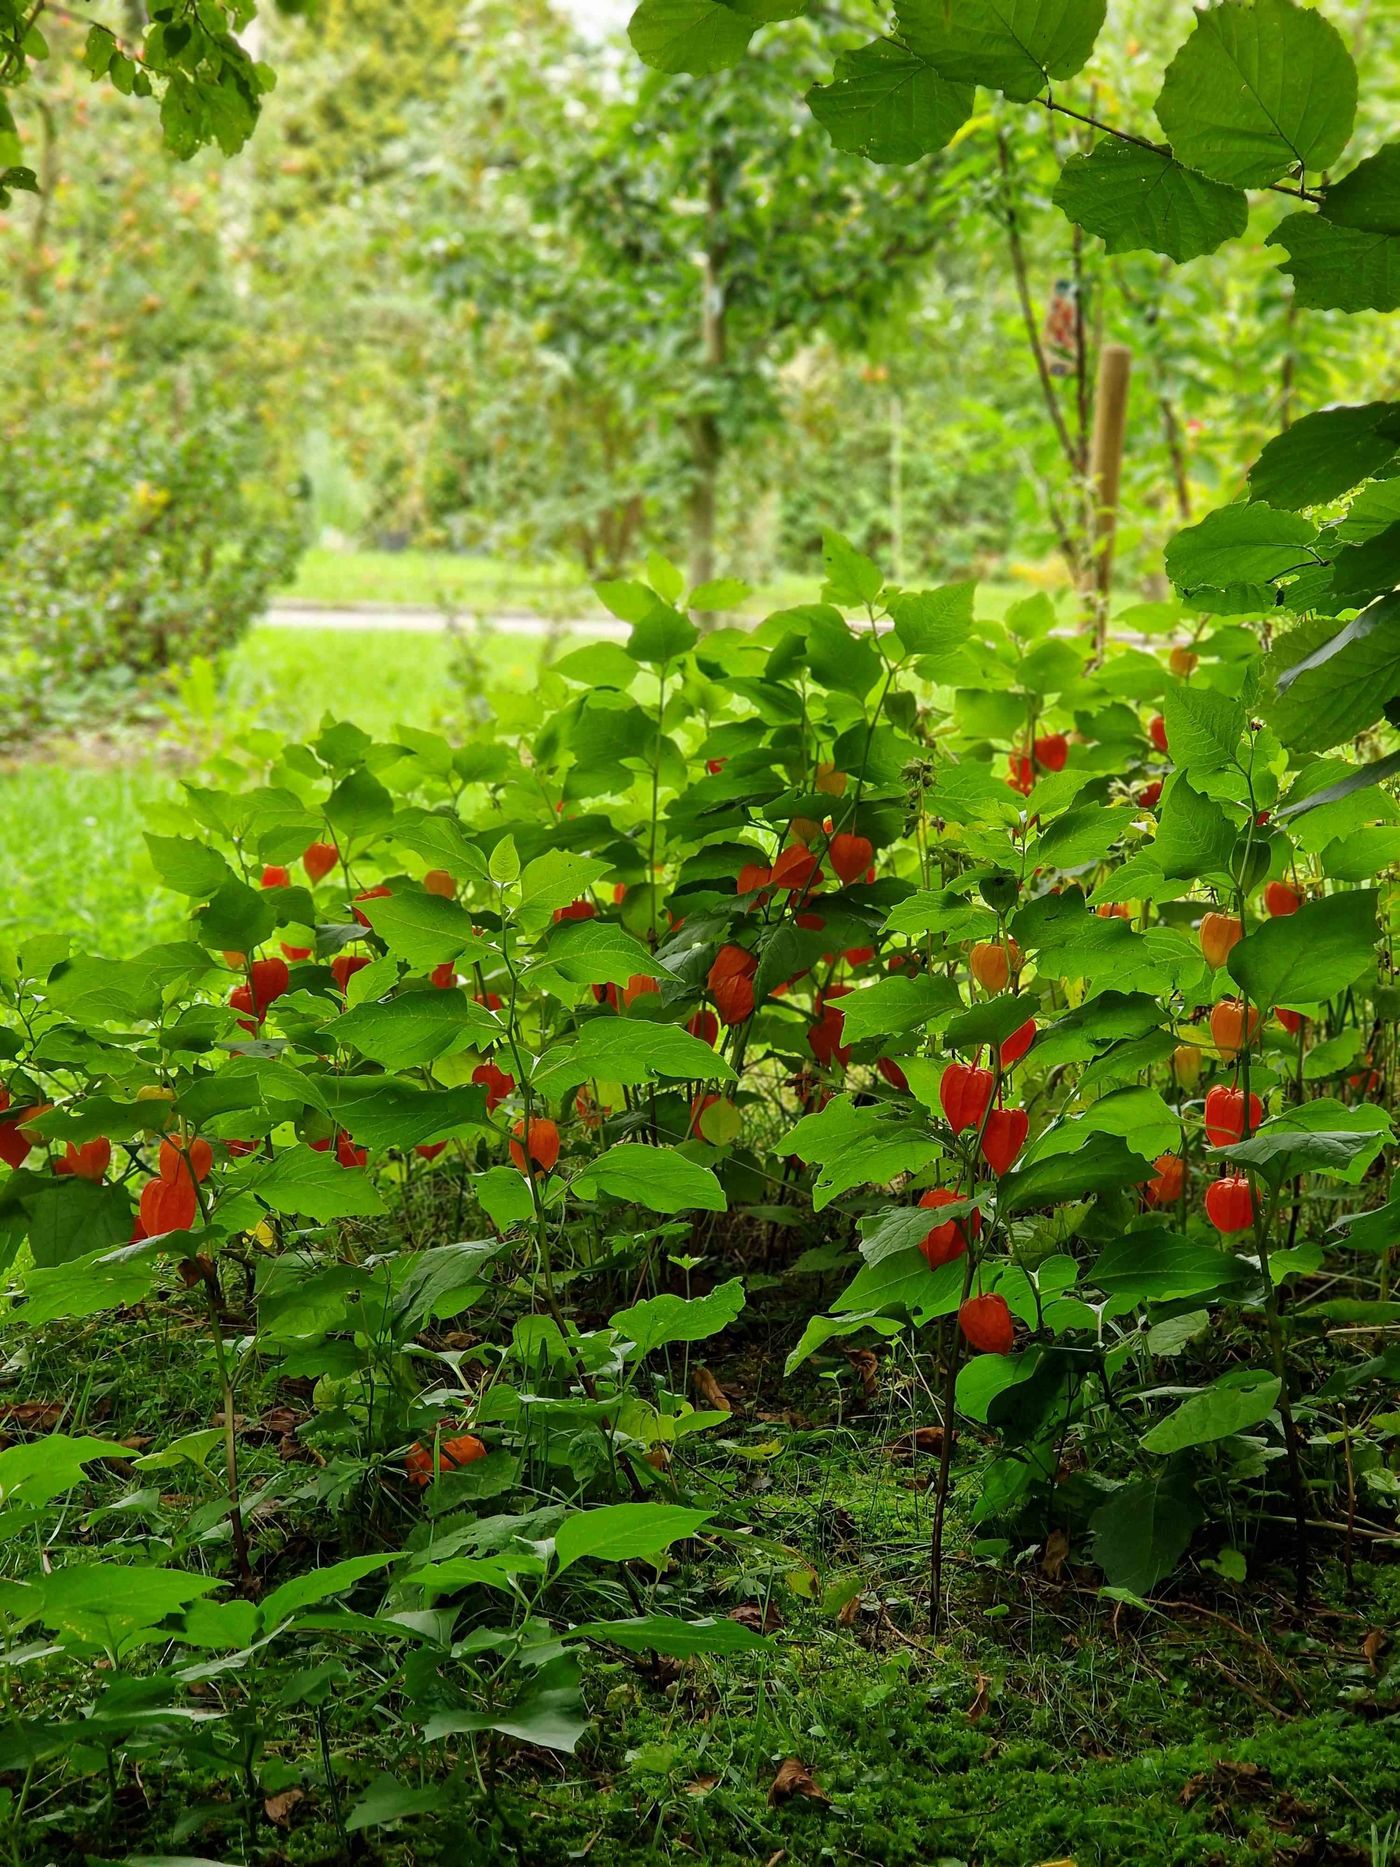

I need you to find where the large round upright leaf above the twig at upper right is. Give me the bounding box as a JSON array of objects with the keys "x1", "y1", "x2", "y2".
[{"x1": 1155, "y1": 0, "x2": 1357, "y2": 189}]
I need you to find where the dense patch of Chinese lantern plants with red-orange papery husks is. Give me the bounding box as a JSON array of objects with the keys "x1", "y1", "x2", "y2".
[{"x1": 0, "y1": 540, "x2": 1394, "y2": 1822}]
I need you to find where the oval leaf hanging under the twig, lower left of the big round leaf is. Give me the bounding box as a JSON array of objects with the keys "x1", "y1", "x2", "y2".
[{"x1": 1053, "y1": 136, "x2": 1249, "y2": 265}]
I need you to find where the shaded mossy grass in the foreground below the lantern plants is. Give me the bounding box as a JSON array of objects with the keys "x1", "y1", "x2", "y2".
[{"x1": 0, "y1": 1298, "x2": 1400, "y2": 1867}]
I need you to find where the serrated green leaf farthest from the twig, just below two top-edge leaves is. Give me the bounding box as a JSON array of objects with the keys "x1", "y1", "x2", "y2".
[{"x1": 806, "y1": 39, "x2": 974, "y2": 162}]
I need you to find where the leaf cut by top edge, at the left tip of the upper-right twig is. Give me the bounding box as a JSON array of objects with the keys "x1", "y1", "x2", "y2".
[{"x1": 896, "y1": 0, "x2": 1105, "y2": 103}]
